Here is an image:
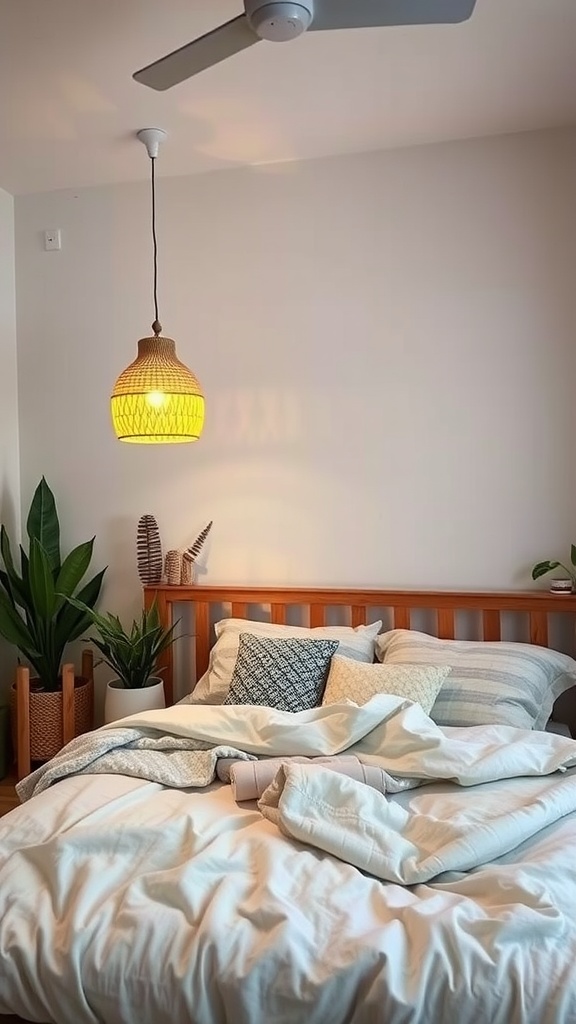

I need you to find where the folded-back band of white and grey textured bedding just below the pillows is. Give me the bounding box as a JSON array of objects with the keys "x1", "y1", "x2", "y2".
[{"x1": 16, "y1": 695, "x2": 576, "y2": 801}]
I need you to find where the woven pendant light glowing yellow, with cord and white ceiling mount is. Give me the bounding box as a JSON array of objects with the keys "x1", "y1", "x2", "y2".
[{"x1": 111, "y1": 128, "x2": 204, "y2": 444}]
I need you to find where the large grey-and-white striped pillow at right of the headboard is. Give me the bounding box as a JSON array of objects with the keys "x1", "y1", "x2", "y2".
[{"x1": 376, "y1": 630, "x2": 576, "y2": 729}]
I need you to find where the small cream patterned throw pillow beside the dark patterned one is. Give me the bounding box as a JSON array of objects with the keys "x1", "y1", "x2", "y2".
[{"x1": 322, "y1": 656, "x2": 450, "y2": 715}]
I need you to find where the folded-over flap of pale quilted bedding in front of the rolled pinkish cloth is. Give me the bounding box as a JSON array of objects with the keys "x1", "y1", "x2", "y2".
[{"x1": 258, "y1": 761, "x2": 576, "y2": 886}]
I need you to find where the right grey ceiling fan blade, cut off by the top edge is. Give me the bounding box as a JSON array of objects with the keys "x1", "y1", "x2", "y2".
[{"x1": 308, "y1": 0, "x2": 476, "y2": 32}]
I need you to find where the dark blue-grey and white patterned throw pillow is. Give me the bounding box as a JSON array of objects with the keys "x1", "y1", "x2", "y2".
[{"x1": 223, "y1": 633, "x2": 338, "y2": 712}]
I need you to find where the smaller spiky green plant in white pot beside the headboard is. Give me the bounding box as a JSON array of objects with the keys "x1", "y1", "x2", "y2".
[{"x1": 70, "y1": 599, "x2": 178, "y2": 723}]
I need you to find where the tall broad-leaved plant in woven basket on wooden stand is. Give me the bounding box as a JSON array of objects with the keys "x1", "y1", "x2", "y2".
[{"x1": 0, "y1": 477, "x2": 106, "y2": 761}]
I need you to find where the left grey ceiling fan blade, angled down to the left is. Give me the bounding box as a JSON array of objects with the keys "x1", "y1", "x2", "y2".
[{"x1": 132, "y1": 14, "x2": 259, "y2": 91}]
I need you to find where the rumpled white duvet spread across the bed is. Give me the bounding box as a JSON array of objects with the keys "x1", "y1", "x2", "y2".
[{"x1": 0, "y1": 698, "x2": 576, "y2": 1024}]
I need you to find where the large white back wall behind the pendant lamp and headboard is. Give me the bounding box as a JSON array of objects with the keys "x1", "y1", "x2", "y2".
[{"x1": 11, "y1": 131, "x2": 576, "y2": 626}]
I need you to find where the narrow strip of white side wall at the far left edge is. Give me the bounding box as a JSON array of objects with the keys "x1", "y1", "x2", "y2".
[{"x1": 0, "y1": 188, "x2": 19, "y2": 700}]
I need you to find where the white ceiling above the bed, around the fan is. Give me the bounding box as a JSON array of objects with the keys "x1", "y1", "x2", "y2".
[{"x1": 0, "y1": 0, "x2": 576, "y2": 195}]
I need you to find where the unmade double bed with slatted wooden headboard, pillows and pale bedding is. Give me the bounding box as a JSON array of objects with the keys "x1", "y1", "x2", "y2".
[{"x1": 0, "y1": 586, "x2": 576, "y2": 1024}]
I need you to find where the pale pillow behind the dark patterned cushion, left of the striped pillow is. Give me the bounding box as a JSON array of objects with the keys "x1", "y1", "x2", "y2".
[{"x1": 190, "y1": 618, "x2": 382, "y2": 705}]
